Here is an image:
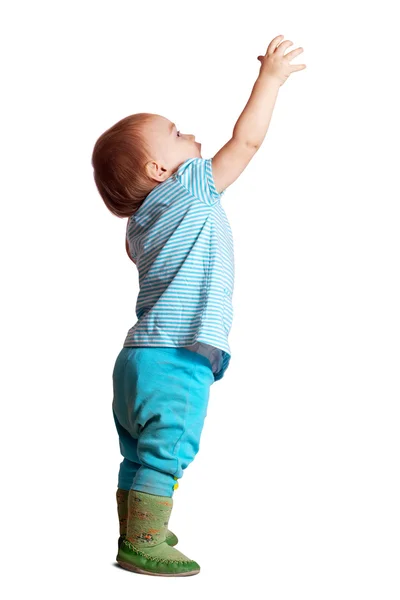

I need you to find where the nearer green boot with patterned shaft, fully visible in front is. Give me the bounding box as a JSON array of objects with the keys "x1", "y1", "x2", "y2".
[{"x1": 117, "y1": 490, "x2": 200, "y2": 577}]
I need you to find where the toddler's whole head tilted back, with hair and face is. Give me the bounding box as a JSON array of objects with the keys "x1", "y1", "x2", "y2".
[{"x1": 92, "y1": 113, "x2": 201, "y2": 218}]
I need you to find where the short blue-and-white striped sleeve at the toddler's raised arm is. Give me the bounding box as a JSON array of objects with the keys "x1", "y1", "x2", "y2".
[{"x1": 176, "y1": 158, "x2": 225, "y2": 204}]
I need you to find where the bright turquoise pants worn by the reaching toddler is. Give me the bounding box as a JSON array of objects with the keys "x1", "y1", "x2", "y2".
[{"x1": 112, "y1": 347, "x2": 214, "y2": 497}]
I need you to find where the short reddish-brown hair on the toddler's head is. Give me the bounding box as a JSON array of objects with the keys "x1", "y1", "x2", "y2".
[{"x1": 92, "y1": 113, "x2": 157, "y2": 218}]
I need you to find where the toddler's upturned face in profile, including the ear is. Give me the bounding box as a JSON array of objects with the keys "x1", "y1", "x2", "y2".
[{"x1": 144, "y1": 115, "x2": 201, "y2": 181}]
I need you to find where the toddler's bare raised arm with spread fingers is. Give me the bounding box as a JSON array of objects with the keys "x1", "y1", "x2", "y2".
[{"x1": 212, "y1": 35, "x2": 306, "y2": 193}]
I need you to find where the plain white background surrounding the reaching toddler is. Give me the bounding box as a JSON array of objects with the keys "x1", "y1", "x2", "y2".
[{"x1": 0, "y1": 0, "x2": 400, "y2": 600}]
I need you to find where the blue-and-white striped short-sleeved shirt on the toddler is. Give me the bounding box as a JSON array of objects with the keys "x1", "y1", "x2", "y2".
[{"x1": 124, "y1": 158, "x2": 234, "y2": 381}]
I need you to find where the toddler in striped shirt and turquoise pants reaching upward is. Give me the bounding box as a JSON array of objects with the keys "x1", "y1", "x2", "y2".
[{"x1": 92, "y1": 35, "x2": 305, "y2": 576}]
